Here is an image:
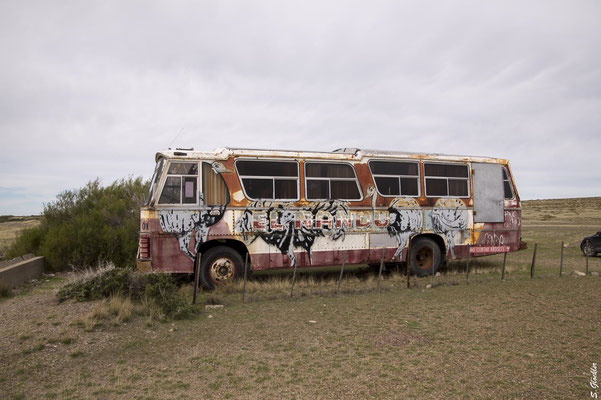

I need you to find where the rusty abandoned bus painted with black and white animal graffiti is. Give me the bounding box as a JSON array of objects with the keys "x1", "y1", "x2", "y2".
[{"x1": 137, "y1": 148, "x2": 524, "y2": 289}]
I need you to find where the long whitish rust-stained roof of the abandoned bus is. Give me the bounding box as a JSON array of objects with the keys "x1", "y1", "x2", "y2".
[{"x1": 156, "y1": 147, "x2": 507, "y2": 164}]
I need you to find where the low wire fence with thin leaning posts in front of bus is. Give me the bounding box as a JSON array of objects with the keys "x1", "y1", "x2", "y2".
[{"x1": 198, "y1": 242, "x2": 601, "y2": 302}]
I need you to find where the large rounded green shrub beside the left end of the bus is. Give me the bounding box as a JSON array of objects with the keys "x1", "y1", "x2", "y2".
[{"x1": 6, "y1": 177, "x2": 148, "y2": 270}]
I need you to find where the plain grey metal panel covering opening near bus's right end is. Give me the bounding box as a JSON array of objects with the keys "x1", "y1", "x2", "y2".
[{"x1": 472, "y1": 163, "x2": 504, "y2": 222}]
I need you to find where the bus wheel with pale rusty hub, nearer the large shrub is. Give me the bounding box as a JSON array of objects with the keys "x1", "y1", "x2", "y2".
[{"x1": 199, "y1": 246, "x2": 244, "y2": 290}]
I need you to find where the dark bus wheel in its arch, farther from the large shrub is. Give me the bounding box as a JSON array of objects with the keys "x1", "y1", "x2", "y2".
[{"x1": 407, "y1": 234, "x2": 446, "y2": 276}]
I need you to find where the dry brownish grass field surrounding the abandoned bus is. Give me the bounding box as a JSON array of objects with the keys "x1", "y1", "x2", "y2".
[{"x1": 0, "y1": 198, "x2": 601, "y2": 399}]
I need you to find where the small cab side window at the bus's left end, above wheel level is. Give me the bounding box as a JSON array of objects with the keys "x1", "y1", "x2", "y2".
[{"x1": 159, "y1": 162, "x2": 198, "y2": 204}]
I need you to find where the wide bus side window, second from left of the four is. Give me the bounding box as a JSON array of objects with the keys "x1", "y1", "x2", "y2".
[{"x1": 305, "y1": 162, "x2": 361, "y2": 200}]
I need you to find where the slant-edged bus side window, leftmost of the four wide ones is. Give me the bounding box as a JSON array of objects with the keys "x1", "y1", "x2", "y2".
[{"x1": 236, "y1": 160, "x2": 299, "y2": 200}]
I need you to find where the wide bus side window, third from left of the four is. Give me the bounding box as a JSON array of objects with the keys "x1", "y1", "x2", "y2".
[{"x1": 369, "y1": 161, "x2": 419, "y2": 197}]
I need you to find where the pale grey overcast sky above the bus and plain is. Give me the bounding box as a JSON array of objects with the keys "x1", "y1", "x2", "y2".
[{"x1": 0, "y1": 0, "x2": 601, "y2": 215}]
